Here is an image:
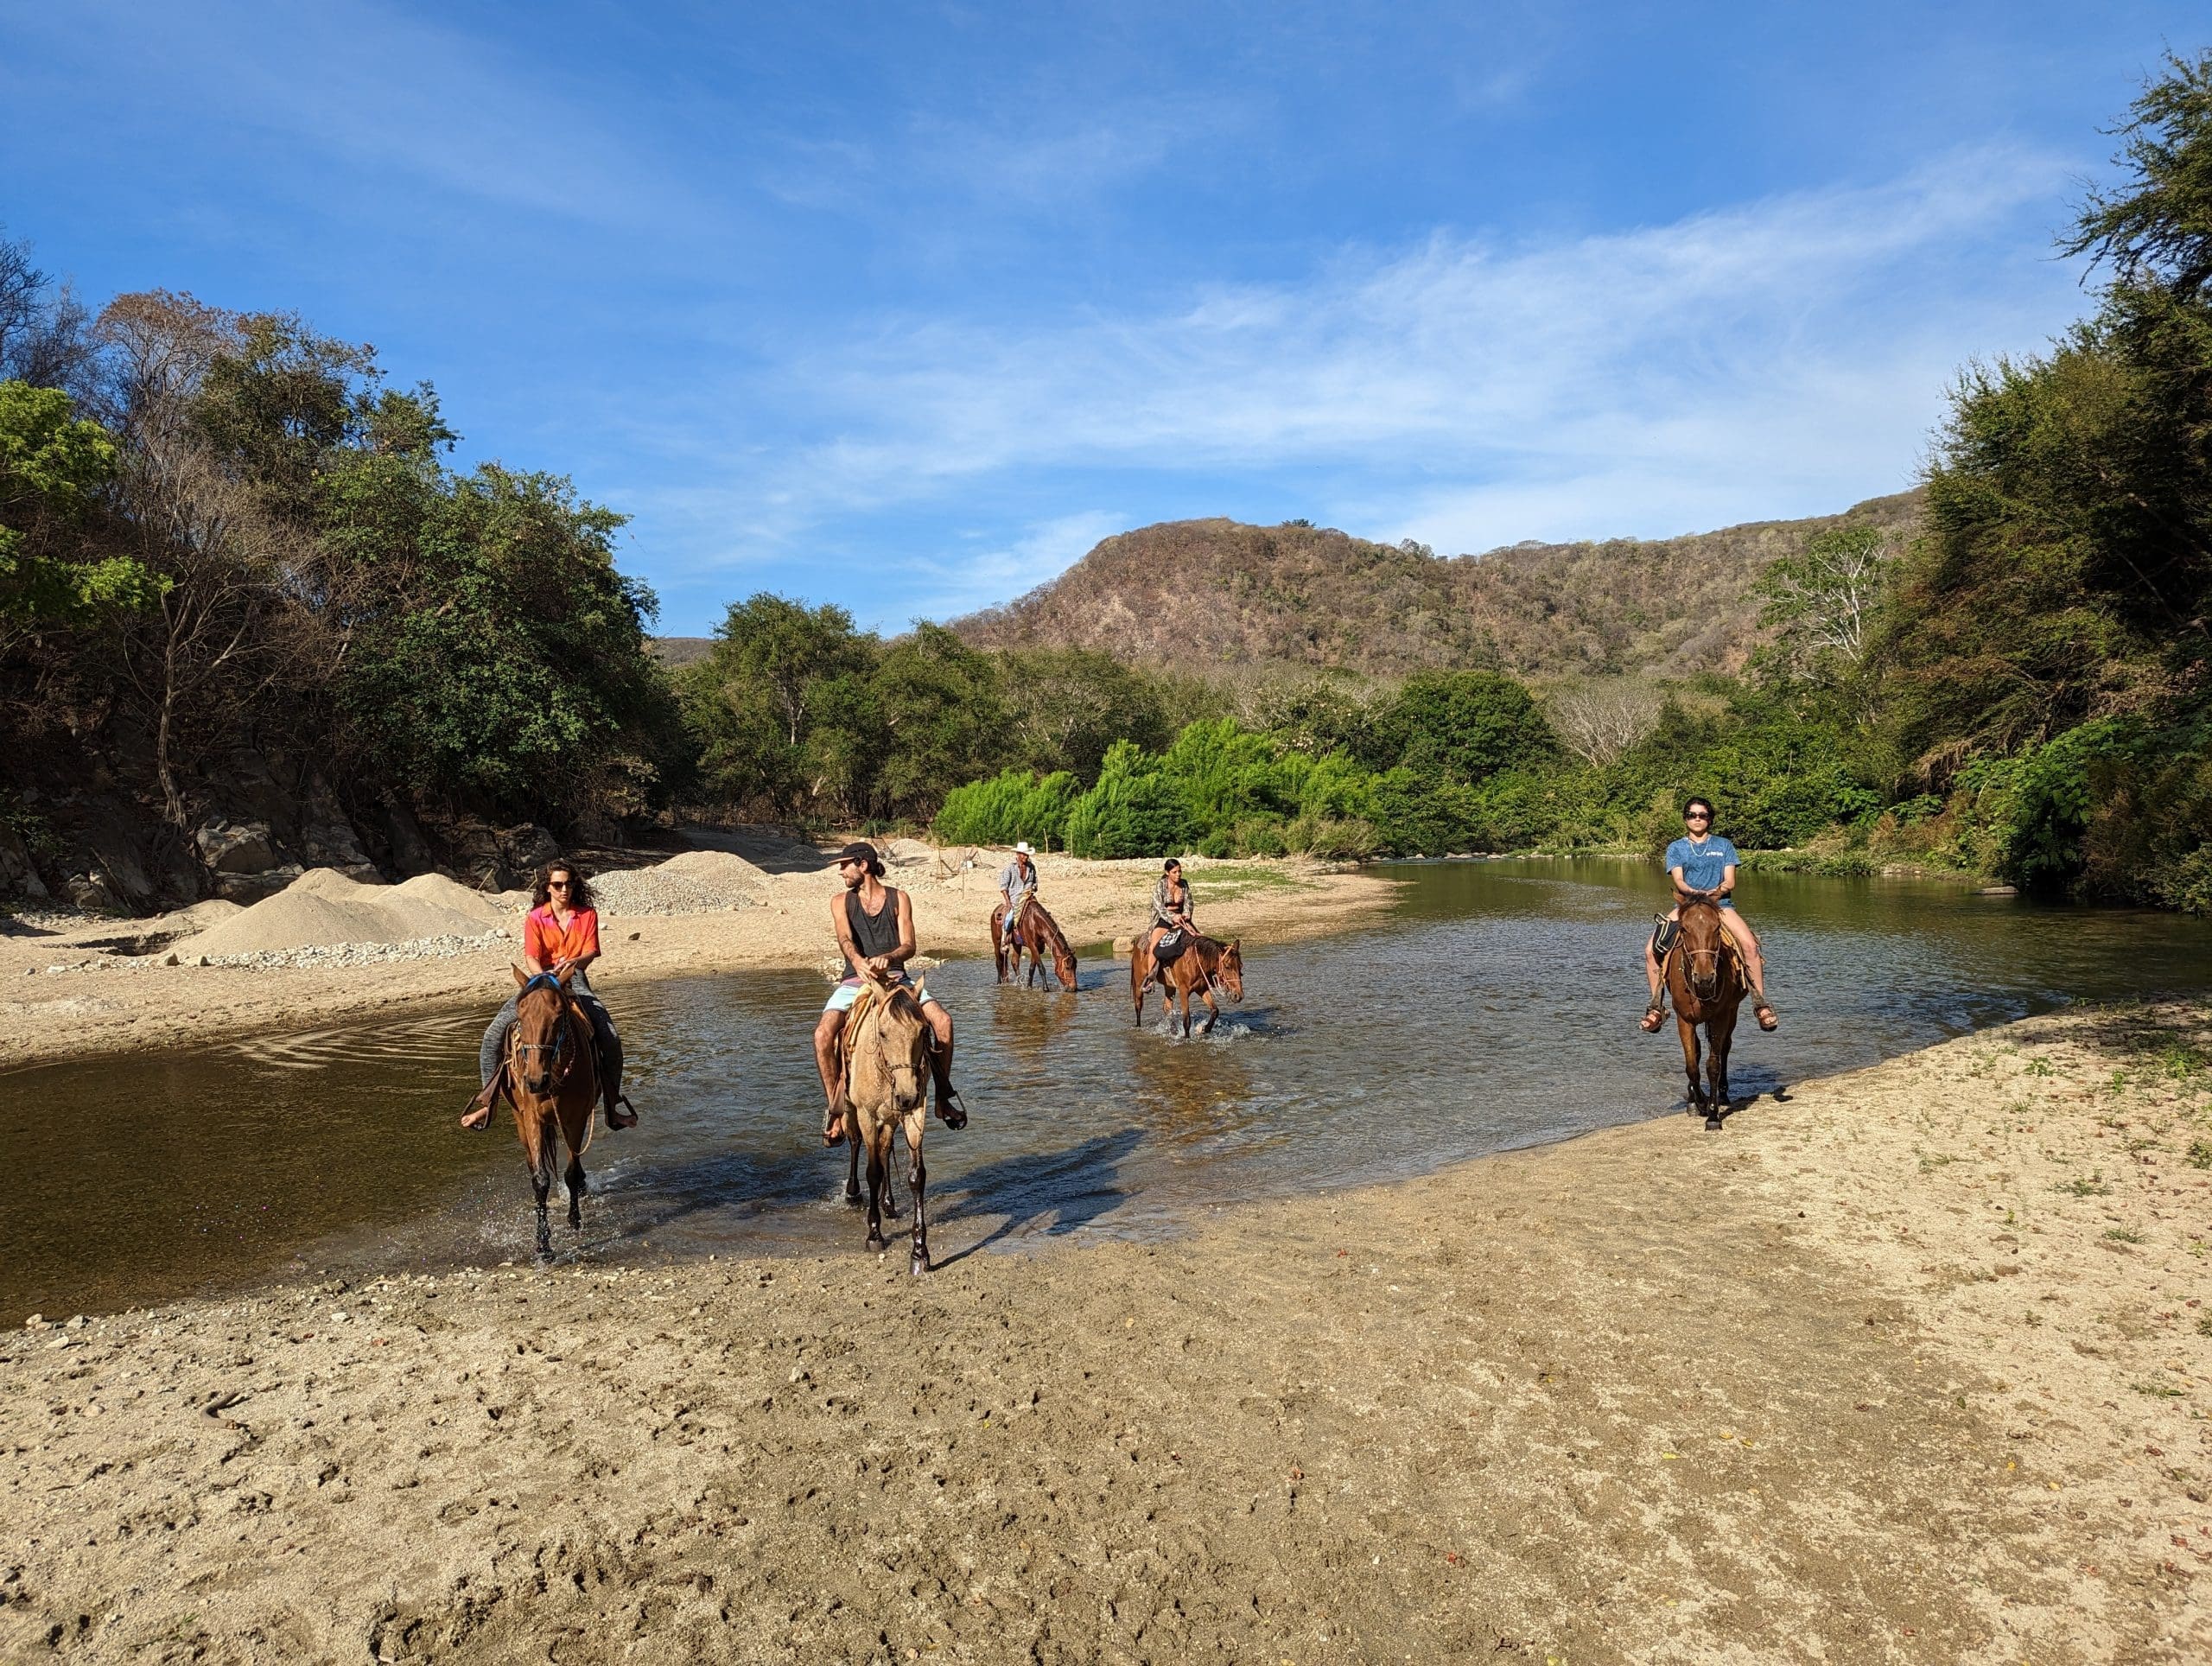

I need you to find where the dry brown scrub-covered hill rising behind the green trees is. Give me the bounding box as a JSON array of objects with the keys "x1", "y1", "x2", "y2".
[{"x1": 951, "y1": 489, "x2": 1923, "y2": 677}]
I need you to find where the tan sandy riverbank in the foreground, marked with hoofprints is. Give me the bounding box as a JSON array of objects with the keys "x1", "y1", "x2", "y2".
[{"x1": 0, "y1": 1002, "x2": 2212, "y2": 1666}]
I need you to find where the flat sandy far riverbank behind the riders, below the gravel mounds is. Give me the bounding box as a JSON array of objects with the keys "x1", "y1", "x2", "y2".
[{"x1": 0, "y1": 852, "x2": 1395, "y2": 1069}]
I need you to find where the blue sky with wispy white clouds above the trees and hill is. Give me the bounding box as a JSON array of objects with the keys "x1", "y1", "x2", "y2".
[{"x1": 0, "y1": 0, "x2": 2212, "y2": 635}]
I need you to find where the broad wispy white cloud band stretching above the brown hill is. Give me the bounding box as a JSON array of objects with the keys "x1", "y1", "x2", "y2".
[{"x1": 685, "y1": 137, "x2": 2063, "y2": 566}]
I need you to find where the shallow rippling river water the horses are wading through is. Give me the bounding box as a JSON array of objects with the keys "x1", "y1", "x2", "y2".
[{"x1": 0, "y1": 861, "x2": 2212, "y2": 1323}]
